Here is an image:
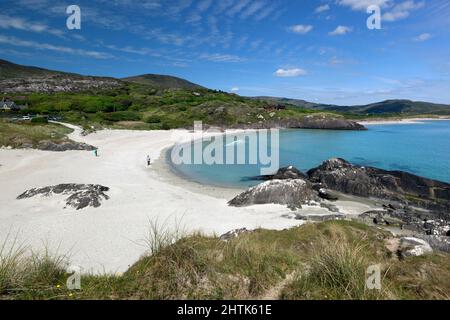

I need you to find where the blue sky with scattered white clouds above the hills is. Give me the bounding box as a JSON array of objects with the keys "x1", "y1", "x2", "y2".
[{"x1": 0, "y1": 0, "x2": 450, "y2": 105}]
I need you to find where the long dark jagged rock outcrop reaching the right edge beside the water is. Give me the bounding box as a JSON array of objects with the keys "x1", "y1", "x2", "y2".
[{"x1": 308, "y1": 159, "x2": 450, "y2": 213}]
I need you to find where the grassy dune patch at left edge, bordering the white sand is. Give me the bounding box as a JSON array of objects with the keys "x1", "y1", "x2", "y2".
[{"x1": 0, "y1": 118, "x2": 72, "y2": 148}]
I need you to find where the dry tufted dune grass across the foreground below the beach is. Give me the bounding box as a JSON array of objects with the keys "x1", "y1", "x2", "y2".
[{"x1": 0, "y1": 222, "x2": 450, "y2": 299}]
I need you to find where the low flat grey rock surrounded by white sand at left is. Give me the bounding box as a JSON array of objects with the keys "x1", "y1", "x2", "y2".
[{"x1": 17, "y1": 184, "x2": 109, "y2": 210}]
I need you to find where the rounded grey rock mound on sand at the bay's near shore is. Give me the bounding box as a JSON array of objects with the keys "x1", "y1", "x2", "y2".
[{"x1": 228, "y1": 179, "x2": 320, "y2": 208}]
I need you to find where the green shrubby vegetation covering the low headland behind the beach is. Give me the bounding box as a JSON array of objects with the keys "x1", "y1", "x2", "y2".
[{"x1": 3, "y1": 83, "x2": 326, "y2": 130}]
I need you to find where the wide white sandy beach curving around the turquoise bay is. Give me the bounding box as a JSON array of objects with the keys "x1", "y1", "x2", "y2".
[{"x1": 0, "y1": 124, "x2": 371, "y2": 273}]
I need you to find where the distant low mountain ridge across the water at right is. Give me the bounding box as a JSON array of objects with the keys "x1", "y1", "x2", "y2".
[{"x1": 255, "y1": 97, "x2": 450, "y2": 116}]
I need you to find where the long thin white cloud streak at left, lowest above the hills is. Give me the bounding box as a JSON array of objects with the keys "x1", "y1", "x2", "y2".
[{"x1": 0, "y1": 35, "x2": 113, "y2": 59}]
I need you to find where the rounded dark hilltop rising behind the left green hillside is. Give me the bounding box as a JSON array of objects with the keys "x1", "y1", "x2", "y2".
[{"x1": 122, "y1": 74, "x2": 205, "y2": 90}]
